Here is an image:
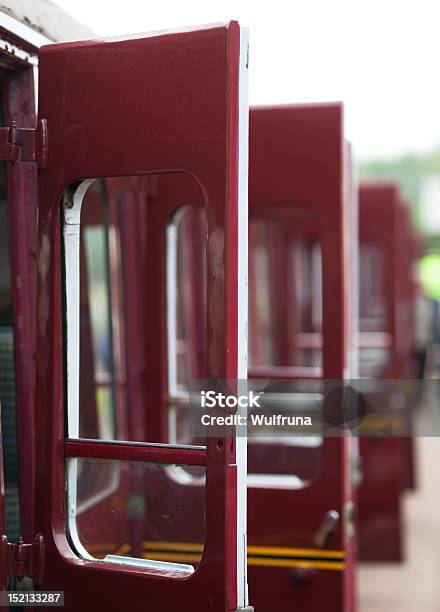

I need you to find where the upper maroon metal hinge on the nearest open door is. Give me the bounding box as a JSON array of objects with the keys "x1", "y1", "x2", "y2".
[{"x1": 0, "y1": 119, "x2": 47, "y2": 169}]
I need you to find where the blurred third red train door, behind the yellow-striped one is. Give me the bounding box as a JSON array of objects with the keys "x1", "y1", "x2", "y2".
[{"x1": 359, "y1": 182, "x2": 413, "y2": 561}]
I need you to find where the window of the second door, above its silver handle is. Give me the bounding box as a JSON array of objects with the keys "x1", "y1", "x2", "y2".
[{"x1": 248, "y1": 214, "x2": 323, "y2": 488}]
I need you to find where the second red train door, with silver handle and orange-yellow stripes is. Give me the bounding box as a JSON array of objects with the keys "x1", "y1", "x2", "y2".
[{"x1": 248, "y1": 105, "x2": 356, "y2": 612}]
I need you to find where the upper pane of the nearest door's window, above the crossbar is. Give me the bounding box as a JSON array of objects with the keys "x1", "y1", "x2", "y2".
[{"x1": 71, "y1": 175, "x2": 208, "y2": 445}]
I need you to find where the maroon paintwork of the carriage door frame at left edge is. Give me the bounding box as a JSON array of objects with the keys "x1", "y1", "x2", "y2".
[{"x1": 2, "y1": 45, "x2": 37, "y2": 541}]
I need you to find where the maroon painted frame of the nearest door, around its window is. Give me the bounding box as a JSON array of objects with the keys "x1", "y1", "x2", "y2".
[{"x1": 36, "y1": 22, "x2": 246, "y2": 612}]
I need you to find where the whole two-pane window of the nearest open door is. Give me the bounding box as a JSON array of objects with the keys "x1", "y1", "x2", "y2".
[{"x1": 63, "y1": 178, "x2": 206, "y2": 577}]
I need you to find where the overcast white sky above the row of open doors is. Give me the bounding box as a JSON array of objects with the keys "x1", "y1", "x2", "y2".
[{"x1": 55, "y1": 0, "x2": 440, "y2": 158}]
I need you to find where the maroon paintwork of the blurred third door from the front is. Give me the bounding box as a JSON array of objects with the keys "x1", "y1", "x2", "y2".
[{"x1": 359, "y1": 183, "x2": 414, "y2": 561}]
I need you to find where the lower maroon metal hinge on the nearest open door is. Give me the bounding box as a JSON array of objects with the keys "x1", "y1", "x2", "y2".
[{"x1": 1, "y1": 534, "x2": 44, "y2": 586}]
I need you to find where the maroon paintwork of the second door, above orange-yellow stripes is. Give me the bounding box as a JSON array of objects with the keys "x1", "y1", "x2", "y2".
[{"x1": 248, "y1": 104, "x2": 356, "y2": 612}]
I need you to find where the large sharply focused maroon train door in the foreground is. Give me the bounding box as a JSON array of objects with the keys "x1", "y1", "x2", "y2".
[{"x1": 29, "y1": 22, "x2": 247, "y2": 611}]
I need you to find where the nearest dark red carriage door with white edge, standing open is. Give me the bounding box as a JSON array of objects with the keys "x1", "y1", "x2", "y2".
[{"x1": 35, "y1": 22, "x2": 248, "y2": 612}]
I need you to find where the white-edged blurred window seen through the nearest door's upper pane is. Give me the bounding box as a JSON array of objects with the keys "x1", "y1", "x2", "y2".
[{"x1": 167, "y1": 205, "x2": 208, "y2": 444}]
